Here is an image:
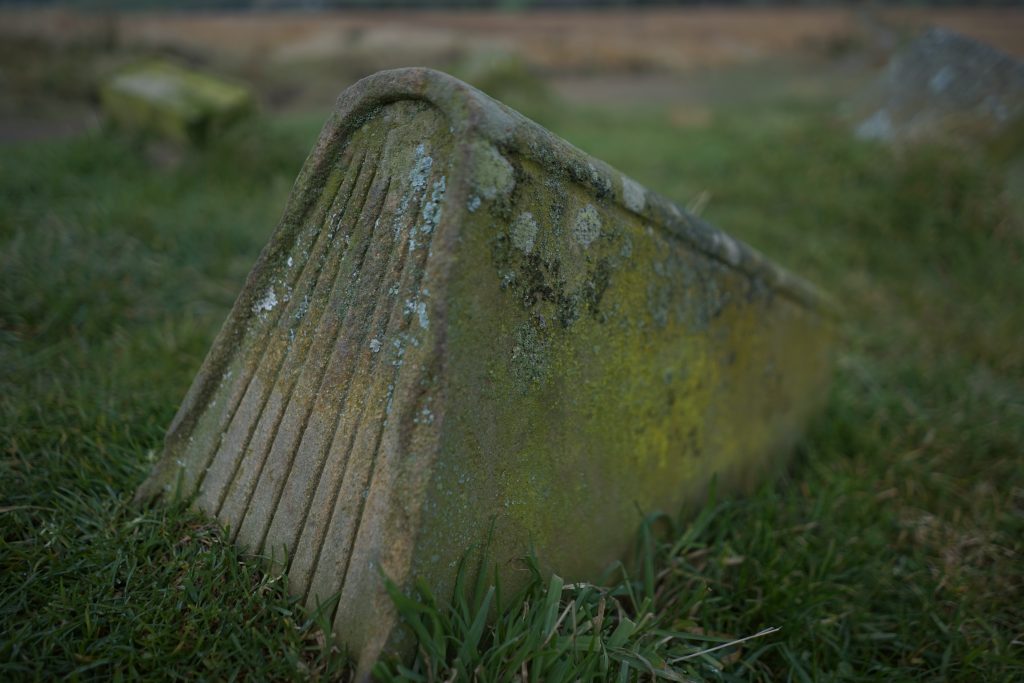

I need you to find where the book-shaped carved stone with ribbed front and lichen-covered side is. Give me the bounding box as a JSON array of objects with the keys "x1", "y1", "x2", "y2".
[{"x1": 139, "y1": 69, "x2": 834, "y2": 672}]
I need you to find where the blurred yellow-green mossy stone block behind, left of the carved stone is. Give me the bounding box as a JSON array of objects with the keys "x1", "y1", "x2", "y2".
[{"x1": 99, "y1": 61, "x2": 253, "y2": 142}]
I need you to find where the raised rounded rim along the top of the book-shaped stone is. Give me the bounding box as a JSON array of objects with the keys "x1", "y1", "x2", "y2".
[{"x1": 326, "y1": 67, "x2": 840, "y2": 315}]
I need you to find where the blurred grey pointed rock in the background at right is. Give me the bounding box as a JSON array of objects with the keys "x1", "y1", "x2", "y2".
[{"x1": 852, "y1": 29, "x2": 1024, "y2": 141}]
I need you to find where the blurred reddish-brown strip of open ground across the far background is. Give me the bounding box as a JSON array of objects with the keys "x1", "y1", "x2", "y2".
[{"x1": 0, "y1": 7, "x2": 1024, "y2": 72}]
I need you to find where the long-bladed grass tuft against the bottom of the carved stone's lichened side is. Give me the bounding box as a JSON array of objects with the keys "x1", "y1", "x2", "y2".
[{"x1": 374, "y1": 512, "x2": 778, "y2": 681}]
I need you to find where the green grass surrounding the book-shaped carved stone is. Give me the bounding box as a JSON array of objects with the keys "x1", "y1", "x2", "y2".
[{"x1": 0, "y1": 97, "x2": 1024, "y2": 681}]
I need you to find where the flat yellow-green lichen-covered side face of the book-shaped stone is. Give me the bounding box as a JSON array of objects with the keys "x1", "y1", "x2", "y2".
[{"x1": 430, "y1": 145, "x2": 820, "y2": 593}]
